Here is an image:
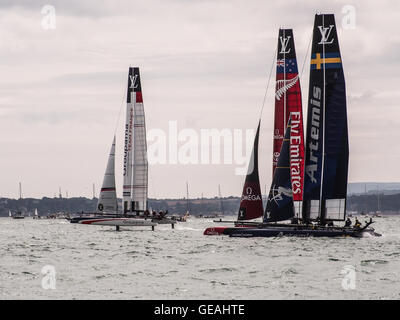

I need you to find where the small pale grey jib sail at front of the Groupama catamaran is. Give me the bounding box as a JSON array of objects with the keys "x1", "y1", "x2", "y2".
[{"x1": 97, "y1": 136, "x2": 118, "y2": 213}]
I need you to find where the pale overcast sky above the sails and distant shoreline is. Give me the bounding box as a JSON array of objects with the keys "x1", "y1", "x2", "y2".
[{"x1": 0, "y1": 0, "x2": 400, "y2": 198}]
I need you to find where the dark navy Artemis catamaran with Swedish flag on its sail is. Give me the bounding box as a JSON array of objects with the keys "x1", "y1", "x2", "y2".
[{"x1": 208, "y1": 14, "x2": 380, "y2": 237}]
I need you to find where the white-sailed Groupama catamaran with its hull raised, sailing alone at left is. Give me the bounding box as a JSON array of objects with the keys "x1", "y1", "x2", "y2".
[{"x1": 78, "y1": 67, "x2": 170, "y2": 230}]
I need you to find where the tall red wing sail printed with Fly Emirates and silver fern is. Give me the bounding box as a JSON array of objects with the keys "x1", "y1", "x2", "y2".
[{"x1": 272, "y1": 29, "x2": 304, "y2": 210}]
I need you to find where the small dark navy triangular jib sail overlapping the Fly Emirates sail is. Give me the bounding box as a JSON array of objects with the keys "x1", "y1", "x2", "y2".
[{"x1": 264, "y1": 120, "x2": 294, "y2": 222}]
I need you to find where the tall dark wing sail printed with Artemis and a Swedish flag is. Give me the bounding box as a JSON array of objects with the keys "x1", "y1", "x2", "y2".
[{"x1": 303, "y1": 14, "x2": 349, "y2": 221}]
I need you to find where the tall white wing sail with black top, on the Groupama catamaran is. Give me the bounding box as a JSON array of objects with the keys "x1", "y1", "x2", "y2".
[{"x1": 123, "y1": 67, "x2": 148, "y2": 213}]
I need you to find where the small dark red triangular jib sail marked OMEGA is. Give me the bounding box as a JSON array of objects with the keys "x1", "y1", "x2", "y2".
[{"x1": 238, "y1": 122, "x2": 263, "y2": 220}]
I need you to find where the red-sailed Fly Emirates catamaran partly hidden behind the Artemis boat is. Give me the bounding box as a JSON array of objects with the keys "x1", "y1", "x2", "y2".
[{"x1": 204, "y1": 29, "x2": 304, "y2": 235}]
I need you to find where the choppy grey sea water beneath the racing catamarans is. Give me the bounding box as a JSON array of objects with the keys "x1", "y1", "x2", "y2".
[{"x1": 0, "y1": 216, "x2": 400, "y2": 299}]
